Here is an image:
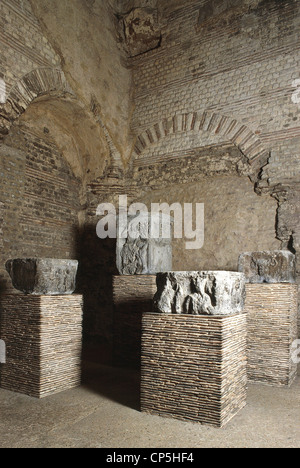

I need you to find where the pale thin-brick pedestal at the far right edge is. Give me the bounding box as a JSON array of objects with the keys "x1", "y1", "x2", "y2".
[{"x1": 245, "y1": 283, "x2": 298, "y2": 386}]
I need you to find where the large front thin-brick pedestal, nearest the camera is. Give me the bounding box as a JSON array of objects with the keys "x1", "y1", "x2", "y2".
[{"x1": 141, "y1": 313, "x2": 247, "y2": 427}]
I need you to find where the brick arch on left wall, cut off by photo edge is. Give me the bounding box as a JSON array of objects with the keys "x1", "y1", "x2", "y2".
[{"x1": 0, "y1": 67, "x2": 74, "y2": 134}]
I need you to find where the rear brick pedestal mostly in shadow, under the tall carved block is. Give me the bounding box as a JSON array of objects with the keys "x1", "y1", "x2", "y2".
[{"x1": 113, "y1": 275, "x2": 157, "y2": 368}]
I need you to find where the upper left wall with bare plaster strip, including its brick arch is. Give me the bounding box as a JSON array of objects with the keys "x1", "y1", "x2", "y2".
[{"x1": 0, "y1": 0, "x2": 127, "y2": 178}]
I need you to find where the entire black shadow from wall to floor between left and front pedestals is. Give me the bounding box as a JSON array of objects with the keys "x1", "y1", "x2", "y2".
[{"x1": 76, "y1": 224, "x2": 150, "y2": 411}]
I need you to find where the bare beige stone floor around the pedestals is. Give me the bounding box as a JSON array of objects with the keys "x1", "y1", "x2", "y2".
[{"x1": 0, "y1": 363, "x2": 300, "y2": 448}]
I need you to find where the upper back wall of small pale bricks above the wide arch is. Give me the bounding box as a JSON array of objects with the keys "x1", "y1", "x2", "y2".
[{"x1": 131, "y1": 0, "x2": 300, "y2": 179}]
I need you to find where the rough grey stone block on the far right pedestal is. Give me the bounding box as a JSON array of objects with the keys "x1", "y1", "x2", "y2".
[{"x1": 239, "y1": 250, "x2": 296, "y2": 283}]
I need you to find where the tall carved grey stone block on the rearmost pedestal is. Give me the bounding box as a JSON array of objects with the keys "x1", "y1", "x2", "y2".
[{"x1": 116, "y1": 213, "x2": 172, "y2": 275}]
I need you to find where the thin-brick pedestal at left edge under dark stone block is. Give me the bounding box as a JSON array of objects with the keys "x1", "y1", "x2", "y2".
[{"x1": 0, "y1": 294, "x2": 82, "y2": 398}]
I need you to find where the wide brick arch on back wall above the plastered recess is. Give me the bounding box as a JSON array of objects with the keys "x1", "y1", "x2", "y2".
[{"x1": 134, "y1": 111, "x2": 270, "y2": 171}]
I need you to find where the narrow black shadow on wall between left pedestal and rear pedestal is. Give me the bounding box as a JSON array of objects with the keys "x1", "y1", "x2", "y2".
[{"x1": 76, "y1": 224, "x2": 117, "y2": 365}]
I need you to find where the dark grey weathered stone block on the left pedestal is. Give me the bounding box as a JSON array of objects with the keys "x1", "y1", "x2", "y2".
[{"x1": 5, "y1": 258, "x2": 78, "y2": 296}]
